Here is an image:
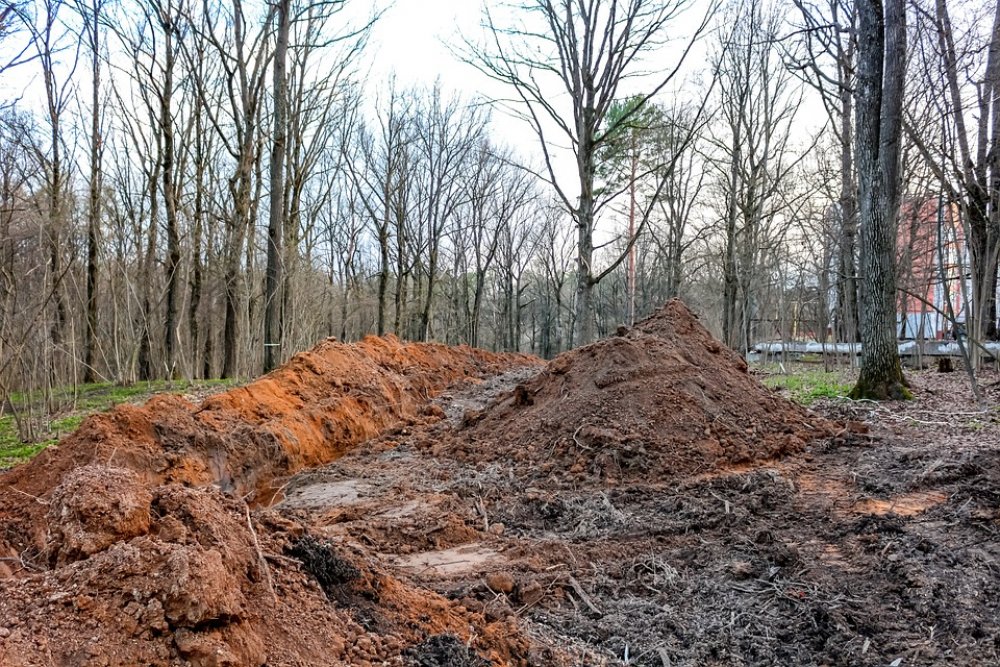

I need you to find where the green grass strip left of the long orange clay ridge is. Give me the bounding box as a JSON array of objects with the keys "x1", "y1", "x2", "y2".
[{"x1": 0, "y1": 380, "x2": 235, "y2": 470}]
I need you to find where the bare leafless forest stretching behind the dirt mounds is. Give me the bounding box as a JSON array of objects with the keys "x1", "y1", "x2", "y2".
[{"x1": 0, "y1": 0, "x2": 1000, "y2": 396}]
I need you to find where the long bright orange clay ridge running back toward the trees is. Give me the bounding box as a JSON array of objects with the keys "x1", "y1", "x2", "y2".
[{"x1": 0, "y1": 336, "x2": 540, "y2": 577}]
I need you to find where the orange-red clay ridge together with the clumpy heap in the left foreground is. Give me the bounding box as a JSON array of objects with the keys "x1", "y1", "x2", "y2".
[{"x1": 0, "y1": 337, "x2": 540, "y2": 667}]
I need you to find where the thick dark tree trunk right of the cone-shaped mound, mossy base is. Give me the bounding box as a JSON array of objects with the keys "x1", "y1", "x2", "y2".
[{"x1": 850, "y1": 0, "x2": 910, "y2": 400}]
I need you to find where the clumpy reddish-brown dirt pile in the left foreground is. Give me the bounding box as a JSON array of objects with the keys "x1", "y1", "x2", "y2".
[{"x1": 0, "y1": 466, "x2": 530, "y2": 667}]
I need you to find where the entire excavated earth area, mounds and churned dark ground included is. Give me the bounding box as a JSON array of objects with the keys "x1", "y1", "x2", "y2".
[{"x1": 0, "y1": 301, "x2": 1000, "y2": 667}]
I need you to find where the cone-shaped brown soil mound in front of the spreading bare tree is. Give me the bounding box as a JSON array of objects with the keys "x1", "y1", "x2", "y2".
[{"x1": 450, "y1": 300, "x2": 833, "y2": 484}]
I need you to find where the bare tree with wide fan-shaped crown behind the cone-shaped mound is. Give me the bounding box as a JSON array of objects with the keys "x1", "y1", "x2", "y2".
[{"x1": 468, "y1": 0, "x2": 715, "y2": 345}]
